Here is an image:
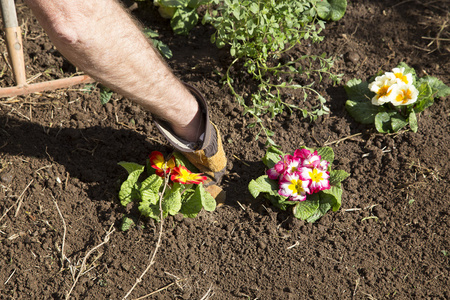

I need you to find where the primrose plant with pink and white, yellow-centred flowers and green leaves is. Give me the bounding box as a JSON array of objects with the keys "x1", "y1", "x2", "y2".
[{"x1": 248, "y1": 147, "x2": 349, "y2": 222}]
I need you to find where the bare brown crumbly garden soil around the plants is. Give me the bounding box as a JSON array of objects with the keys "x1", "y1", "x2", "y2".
[{"x1": 0, "y1": 0, "x2": 450, "y2": 299}]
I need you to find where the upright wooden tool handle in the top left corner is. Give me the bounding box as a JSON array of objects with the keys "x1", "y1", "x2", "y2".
[{"x1": 1, "y1": 0, "x2": 27, "y2": 86}]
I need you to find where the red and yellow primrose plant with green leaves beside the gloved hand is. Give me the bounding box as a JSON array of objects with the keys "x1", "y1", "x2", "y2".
[{"x1": 119, "y1": 151, "x2": 216, "y2": 229}]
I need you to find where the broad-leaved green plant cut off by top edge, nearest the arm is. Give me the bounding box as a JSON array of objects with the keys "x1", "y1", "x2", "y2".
[{"x1": 153, "y1": 0, "x2": 211, "y2": 35}]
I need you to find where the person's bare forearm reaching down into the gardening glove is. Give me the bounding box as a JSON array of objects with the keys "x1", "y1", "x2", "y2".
[{"x1": 26, "y1": 0, "x2": 204, "y2": 141}]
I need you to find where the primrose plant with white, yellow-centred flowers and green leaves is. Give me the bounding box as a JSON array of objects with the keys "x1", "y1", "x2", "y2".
[{"x1": 345, "y1": 63, "x2": 450, "y2": 133}]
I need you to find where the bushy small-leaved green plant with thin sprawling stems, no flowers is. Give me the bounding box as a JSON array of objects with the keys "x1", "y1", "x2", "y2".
[{"x1": 203, "y1": 0, "x2": 346, "y2": 144}]
